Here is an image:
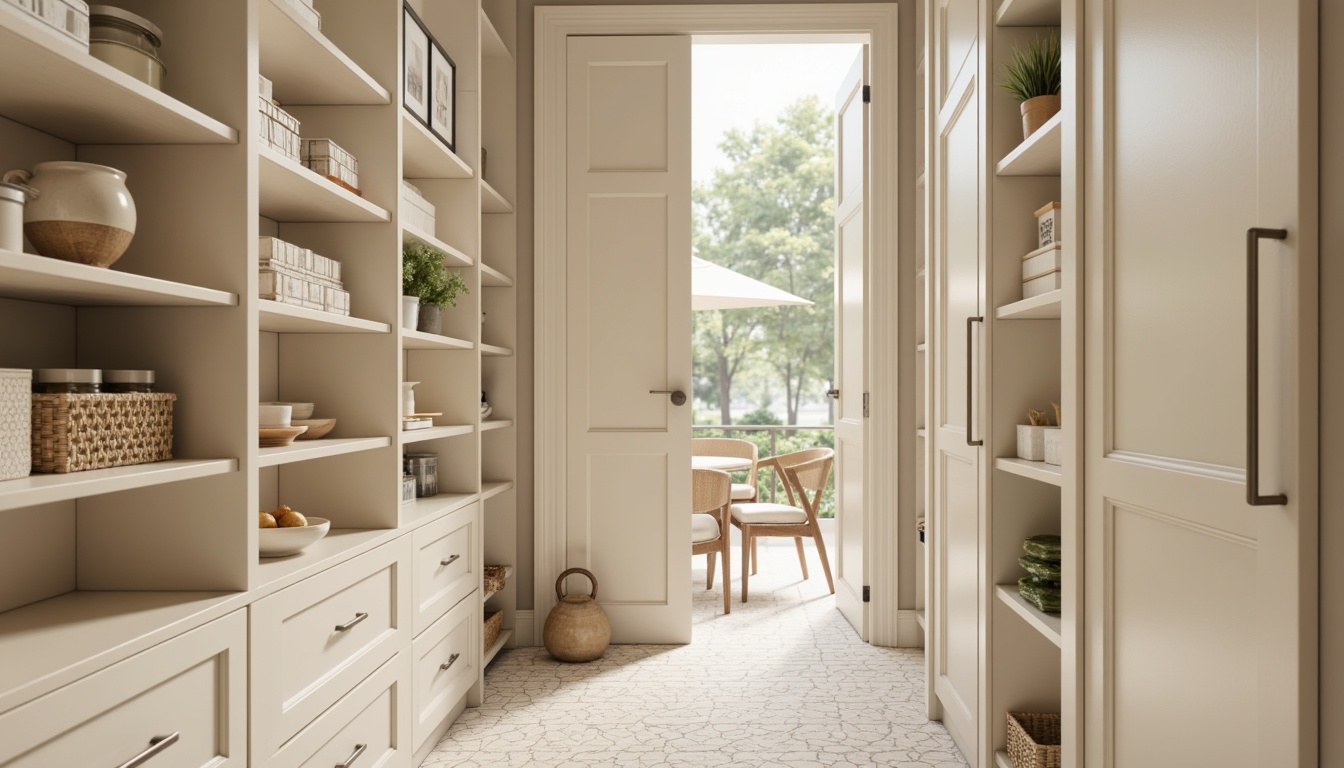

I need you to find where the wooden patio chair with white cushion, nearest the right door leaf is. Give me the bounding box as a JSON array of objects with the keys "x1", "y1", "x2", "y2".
[{"x1": 731, "y1": 448, "x2": 836, "y2": 603}]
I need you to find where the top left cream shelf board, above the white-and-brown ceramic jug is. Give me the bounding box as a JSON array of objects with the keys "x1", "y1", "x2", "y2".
[{"x1": 0, "y1": 3, "x2": 238, "y2": 143}]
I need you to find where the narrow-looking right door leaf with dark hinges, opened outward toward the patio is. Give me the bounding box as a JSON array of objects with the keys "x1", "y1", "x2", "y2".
[{"x1": 835, "y1": 46, "x2": 868, "y2": 640}]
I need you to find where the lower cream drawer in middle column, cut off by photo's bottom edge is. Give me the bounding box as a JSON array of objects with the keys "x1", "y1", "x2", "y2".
[{"x1": 260, "y1": 652, "x2": 411, "y2": 768}]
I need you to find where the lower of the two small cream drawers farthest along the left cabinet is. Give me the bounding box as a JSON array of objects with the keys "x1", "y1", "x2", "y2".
[{"x1": 411, "y1": 594, "x2": 481, "y2": 749}]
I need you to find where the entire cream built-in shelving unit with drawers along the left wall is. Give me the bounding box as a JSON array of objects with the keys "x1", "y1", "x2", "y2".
[{"x1": 0, "y1": 0, "x2": 519, "y2": 765}]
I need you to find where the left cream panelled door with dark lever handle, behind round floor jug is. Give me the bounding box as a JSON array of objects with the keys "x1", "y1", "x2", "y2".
[{"x1": 566, "y1": 36, "x2": 691, "y2": 643}]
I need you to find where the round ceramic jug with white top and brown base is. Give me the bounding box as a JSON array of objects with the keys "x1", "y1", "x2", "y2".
[{"x1": 4, "y1": 160, "x2": 136, "y2": 266}]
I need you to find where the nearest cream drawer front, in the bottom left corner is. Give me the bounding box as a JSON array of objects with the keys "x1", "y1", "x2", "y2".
[{"x1": 0, "y1": 611, "x2": 247, "y2": 768}]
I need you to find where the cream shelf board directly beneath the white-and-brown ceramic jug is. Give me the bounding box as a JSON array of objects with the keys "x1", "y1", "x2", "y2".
[{"x1": 0, "y1": 250, "x2": 238, "y2": 307}]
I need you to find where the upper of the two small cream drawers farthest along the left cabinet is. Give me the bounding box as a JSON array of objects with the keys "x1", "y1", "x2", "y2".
[{"x1": 411, "y1": 503, "x2": 481, "y2": 635}]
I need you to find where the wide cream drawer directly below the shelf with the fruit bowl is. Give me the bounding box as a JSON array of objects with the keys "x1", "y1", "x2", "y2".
[{"x1": 251, "y1": 537, "x2": 411, "y2": 760}]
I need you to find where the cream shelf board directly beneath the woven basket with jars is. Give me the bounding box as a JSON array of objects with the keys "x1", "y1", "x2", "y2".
[{"x1": 0, "y1": 459, "x2": 238, "y2": 513}]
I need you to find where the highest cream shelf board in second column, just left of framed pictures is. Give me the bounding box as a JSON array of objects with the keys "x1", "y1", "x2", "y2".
[{"x1": 257, "y1": 0, "x2": 391, "y2": 105}]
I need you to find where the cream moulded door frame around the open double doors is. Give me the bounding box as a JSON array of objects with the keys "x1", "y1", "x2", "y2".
[{"x1": 532, "y1": 3, "x2": 918, "y2": 646}]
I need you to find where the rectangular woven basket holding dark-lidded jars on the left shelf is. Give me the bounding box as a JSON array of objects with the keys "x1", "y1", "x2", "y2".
[{"x1": 32, "y1": 393, "x2": 177, "y2": 472}]
